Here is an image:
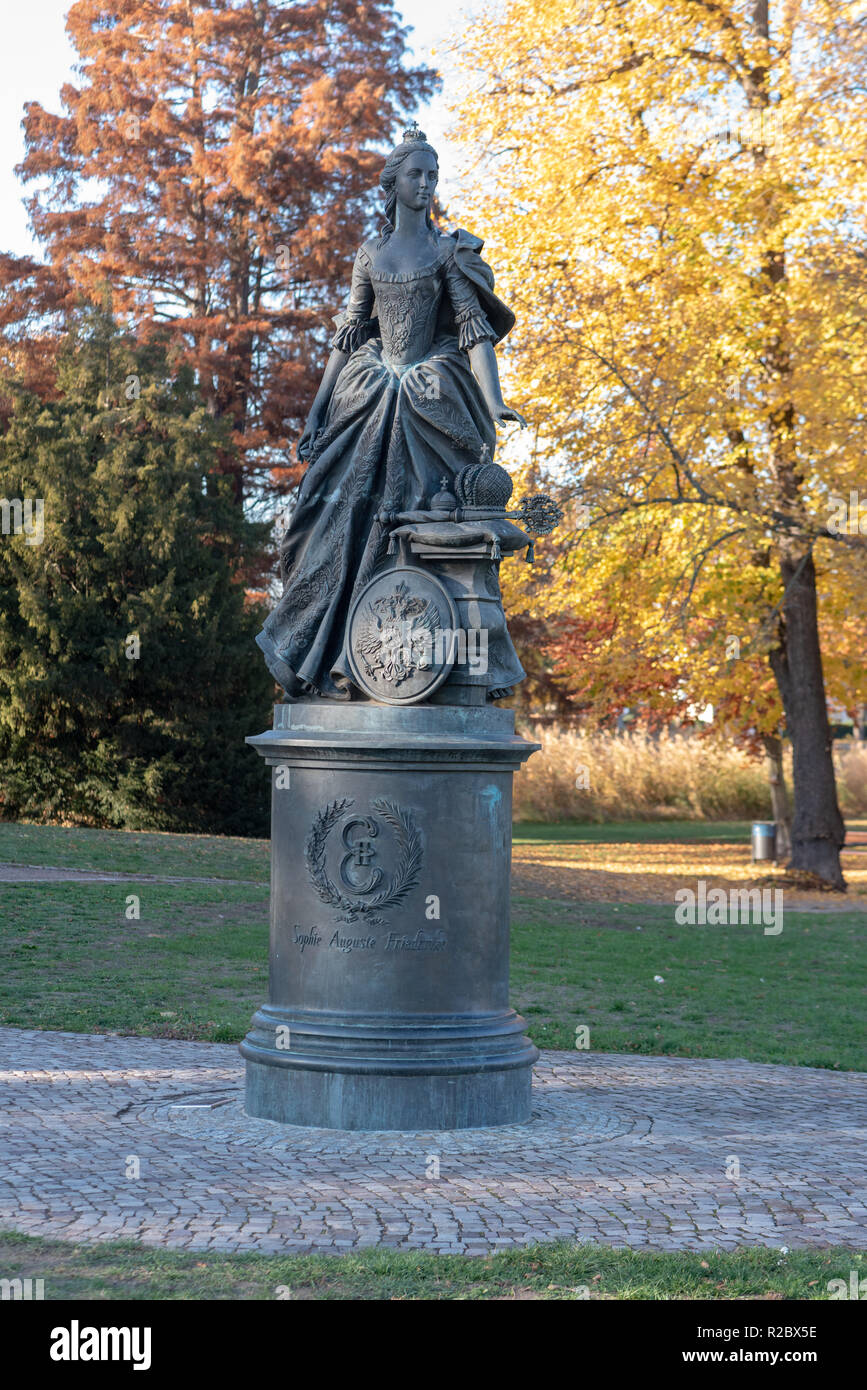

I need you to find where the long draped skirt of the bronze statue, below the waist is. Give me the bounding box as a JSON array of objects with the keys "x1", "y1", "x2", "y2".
[{"x1": 257, "y1": 336, "x2": 496, "y2": 699}]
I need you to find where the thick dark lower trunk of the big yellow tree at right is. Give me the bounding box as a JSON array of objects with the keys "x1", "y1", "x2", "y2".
[{"x1": 770, "y1": 545, "x2": 846, "y2": 891}]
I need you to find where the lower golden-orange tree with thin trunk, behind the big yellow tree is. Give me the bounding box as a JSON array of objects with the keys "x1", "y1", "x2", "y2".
[{"x1": 503, "y1": 474, "x2": 867, "y2": 858}]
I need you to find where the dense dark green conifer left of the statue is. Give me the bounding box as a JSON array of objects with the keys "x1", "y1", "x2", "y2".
[{"x1": 0, "y1": 309, "x2": 274, "y2": 834}]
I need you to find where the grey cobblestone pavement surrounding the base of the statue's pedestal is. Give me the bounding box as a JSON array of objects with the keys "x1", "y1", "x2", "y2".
[{"x1": 0, "y1": 1029, "x2": 867, "y2": 1254}]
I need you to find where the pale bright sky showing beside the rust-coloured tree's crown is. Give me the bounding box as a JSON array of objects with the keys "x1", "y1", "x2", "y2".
[{"x1": 0, "y1": 0, "x2": 478, "y2": 256}]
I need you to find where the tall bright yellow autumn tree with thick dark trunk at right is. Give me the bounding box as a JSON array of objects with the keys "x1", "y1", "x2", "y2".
[{"x1": 459, "y1": 0, "x2": 867, "y2": 887}]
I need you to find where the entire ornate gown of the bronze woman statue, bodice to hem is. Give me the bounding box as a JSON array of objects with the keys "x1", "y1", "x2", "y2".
[{"x1": 257, "y1": 229, "x2": 514, "y2": 699}]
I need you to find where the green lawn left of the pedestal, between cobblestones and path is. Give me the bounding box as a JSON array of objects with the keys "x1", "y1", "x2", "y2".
[{"x1": 0, "y1": 883, "x2": 268, "y2": 1043}]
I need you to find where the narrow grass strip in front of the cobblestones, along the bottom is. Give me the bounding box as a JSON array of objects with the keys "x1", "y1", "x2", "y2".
[{"x1": 0, "y1": 1233, "x2": 863, "y2": 1300}]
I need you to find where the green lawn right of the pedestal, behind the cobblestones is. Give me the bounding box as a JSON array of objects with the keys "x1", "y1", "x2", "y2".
[{"x1": 511, "y1": 898, "x2": 867, "y2": 1070}]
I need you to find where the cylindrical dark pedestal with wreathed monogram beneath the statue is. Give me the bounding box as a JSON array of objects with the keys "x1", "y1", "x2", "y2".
[{"x1": 240, "y1": 701, "x2": 539, "y2": 1130}]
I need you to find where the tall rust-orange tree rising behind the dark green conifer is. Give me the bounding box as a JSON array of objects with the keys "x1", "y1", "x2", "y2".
[{"x1": 0, "y1": 0, "x2": 434, "y2": 498}]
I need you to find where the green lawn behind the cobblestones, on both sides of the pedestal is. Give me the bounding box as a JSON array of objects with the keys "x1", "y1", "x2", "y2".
[{"x1": 0, "y1": 826, "x2": 867, "y2": 1070}]
